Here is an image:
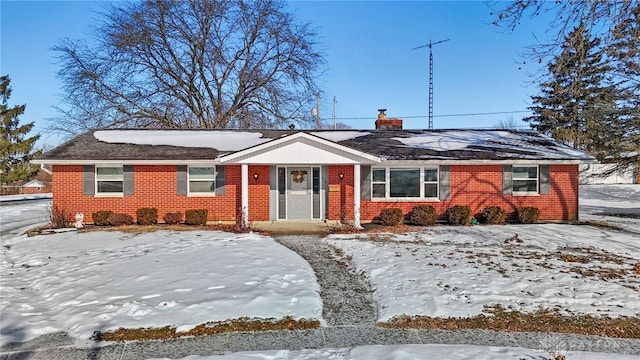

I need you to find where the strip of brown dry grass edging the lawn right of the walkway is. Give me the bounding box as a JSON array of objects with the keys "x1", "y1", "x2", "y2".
[{"x1": 378, "y1": 305, "x2": 640, "y2": 339}]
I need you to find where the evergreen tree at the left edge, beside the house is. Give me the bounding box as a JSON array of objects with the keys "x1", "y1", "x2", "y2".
[{"x1": 0, "y1": 76, "x2": 40, "y2": 185}]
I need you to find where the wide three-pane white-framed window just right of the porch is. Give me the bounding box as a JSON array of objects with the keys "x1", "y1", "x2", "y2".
[{"x1": 371, "y1": 167, "x2": 438, "y2": 199}]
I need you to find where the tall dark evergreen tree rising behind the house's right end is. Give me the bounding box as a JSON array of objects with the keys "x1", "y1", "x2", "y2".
[{"x1": 524, "y1": 25, "x2": 616, "y2": 152}]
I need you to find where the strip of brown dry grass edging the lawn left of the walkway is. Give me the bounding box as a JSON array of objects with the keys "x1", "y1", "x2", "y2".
[{"x1": 91, "y1": 317, "x2": 320, "y2": 341}]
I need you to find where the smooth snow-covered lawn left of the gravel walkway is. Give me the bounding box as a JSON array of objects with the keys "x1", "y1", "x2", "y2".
[{"x1": 0, "y1": 231, "x2": 322, "y2": 344}]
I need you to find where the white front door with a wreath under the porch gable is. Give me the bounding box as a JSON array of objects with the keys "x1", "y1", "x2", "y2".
[{"x1": 286, "y1": 167, "x2": 313, "y2": 220}]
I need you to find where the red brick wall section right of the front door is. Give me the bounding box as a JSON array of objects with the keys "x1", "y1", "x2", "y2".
[{"x1": 338, "y1": 165, "x2": 578, "y2": 221}]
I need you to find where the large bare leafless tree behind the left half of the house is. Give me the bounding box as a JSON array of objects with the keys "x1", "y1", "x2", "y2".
[{"x1": 52, "y1": 0, "x2": 324, "y2": 133}]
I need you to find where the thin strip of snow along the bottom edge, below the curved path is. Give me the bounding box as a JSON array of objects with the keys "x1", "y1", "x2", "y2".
[{"x1": 150, "y1": 345, "x2": 638, "y2": 360}]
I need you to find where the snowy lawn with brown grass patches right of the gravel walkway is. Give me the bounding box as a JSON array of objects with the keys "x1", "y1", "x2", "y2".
[{"x1": 327, "y1": 185, "x2": 640, "y2": 321}]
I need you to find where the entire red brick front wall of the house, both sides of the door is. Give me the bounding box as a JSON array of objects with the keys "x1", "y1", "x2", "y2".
[{"x1": 53, "y1": 165, "x2": 578, "y2": 222}]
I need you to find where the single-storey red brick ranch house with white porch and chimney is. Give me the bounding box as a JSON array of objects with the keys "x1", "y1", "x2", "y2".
[{"x1": 34, "y1": 111, "x2": 594, "y2": 226}]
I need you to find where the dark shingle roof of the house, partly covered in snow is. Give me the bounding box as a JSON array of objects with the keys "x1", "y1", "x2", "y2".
[{"x1": 36, "y1": 129, "x2": 594, "y2": 163}]
